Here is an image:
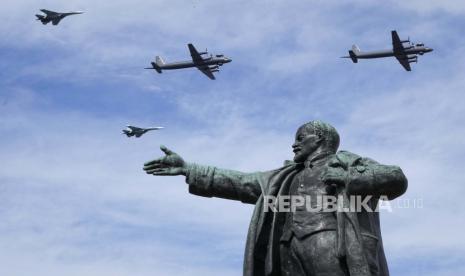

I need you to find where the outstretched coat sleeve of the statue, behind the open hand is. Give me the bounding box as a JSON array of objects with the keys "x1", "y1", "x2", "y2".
[{"x1": 186, "y1": 164, "x2": 268, "y2": 204}]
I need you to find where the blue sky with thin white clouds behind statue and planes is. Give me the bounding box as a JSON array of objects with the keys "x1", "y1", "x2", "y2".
[{"x1": 0, "y1": 0, "x2": 465, "y2": 276}]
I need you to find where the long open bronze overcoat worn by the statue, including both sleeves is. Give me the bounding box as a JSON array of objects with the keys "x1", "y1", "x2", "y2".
[{"x1": 186, "y1": 151, "x2": 407, "y2": 276}]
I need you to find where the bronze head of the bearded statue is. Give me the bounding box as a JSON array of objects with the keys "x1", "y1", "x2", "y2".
[{"x1": 292, "y1": 120, "x2": 339, "y2": 163}]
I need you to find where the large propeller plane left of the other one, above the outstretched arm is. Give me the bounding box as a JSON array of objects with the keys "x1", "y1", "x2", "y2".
[{"x1": 145, "y1": 43, "x2": 231, "y2": 80}]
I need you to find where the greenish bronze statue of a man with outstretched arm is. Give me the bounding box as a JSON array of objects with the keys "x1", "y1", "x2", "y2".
[{"x1": 144, "y1": 121, "x2": 407, "y2": 276}]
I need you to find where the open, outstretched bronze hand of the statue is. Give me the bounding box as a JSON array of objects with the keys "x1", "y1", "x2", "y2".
[{"x1": 144, "y1": 146, "x2": 187, "y2": 175}]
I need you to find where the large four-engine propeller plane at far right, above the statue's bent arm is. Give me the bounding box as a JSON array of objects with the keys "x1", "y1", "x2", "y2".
[{"x1": 342, "y1": 31, "x2": 433, "y2": 71}]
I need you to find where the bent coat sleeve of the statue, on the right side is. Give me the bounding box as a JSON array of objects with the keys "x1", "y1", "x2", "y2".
[{"x1": 348, "y1": 158, "x2": 408, "y2": 199}]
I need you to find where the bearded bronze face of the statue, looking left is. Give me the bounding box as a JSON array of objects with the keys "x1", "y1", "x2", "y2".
[{"x1": 292, "y1": 126, "x2": 321, "y2": 163}]
